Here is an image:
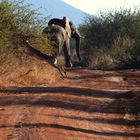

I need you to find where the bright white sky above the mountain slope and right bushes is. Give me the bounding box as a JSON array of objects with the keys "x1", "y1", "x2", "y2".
[{"x1": 62, "y1": 0, "x2": 140, "y2": 14}]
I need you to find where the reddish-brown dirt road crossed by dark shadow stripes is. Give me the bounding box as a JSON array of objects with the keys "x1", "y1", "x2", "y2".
[{"x1": 0, "y1": 69, "x2": 140, "y2": 140}]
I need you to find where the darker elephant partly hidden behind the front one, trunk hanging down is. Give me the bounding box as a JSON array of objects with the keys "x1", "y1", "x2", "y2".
[{"x1": 48, "y1": 17, "x2": 82, "y2": 61}]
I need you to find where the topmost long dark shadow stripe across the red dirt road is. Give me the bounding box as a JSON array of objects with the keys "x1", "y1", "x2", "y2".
[{"x1": 0, "y1": 86, "x2": 136, "y2": 99}]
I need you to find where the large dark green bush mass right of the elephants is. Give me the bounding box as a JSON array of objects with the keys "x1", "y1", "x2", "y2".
[{"x1": 80, "y1": 8, "x2": 140, "y2": 69}]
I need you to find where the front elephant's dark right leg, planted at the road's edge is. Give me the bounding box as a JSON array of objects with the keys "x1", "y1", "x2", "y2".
[{"x1": 64, "y1": 41, "x2": 72, "y2": 67}]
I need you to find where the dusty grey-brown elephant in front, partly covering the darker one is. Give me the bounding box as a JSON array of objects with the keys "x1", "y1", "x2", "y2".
[{"x1": 42, "y1": 24, "x2": 72, "y2": 73}]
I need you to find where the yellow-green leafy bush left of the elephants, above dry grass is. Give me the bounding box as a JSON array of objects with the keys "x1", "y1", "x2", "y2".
[{"x1": 0, "y1": 0, "x2": 49, "y2": 63}]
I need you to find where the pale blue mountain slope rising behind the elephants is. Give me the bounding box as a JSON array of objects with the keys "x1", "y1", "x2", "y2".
[{"x1": 26, "y1": 0, "x2": 87, "y2": 25}]
